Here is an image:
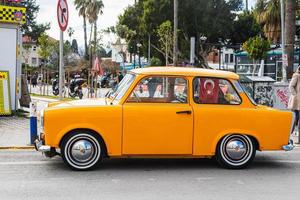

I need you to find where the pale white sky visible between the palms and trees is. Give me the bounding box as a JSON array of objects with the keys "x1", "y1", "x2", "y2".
[{"x1": 36, "y1": 0, "x2": 256, "y2": 48}]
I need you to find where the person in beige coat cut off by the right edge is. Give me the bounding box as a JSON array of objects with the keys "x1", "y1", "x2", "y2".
[{"x1": 288, "y1": 65, "x2": 300, "y2": 136}]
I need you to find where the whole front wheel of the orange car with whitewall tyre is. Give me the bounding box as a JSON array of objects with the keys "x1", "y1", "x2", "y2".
[{"x1": 61, "y1": 132, "x2": 103, "y2": 170}]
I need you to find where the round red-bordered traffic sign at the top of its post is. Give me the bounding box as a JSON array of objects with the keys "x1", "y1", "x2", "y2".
[{"x1": 57, "y1": 0, "x2": 69, "y2": 31}]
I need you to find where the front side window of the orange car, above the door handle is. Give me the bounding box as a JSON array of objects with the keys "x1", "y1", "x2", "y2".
[{"x1": 127, "y1": 76, "x2": 188, "y2": 103}]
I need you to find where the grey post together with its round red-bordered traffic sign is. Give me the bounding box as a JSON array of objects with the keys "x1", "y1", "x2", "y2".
[{"x1": 57, "y1": 0, "x2": 69, "y2": 100}]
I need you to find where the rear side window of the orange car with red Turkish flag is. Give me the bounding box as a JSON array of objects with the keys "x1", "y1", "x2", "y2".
[{"x1": 193, "y1": 77, "x2": 242, "y2": 105}]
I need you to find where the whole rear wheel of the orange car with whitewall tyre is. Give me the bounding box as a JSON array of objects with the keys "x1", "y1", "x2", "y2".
[{"x1": 216, "y1": 134, "x2": 256, "y2": 169}]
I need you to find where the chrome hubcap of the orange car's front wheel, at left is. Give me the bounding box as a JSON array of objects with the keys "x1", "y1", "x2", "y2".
[{"x1": 71, "y1": 140, "x2": 95, "y2": 162}]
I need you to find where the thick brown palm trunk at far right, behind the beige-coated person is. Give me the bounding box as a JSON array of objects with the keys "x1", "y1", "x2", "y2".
[{"x1": 285, "y1": 0, "x2": 296, "y2": 79}]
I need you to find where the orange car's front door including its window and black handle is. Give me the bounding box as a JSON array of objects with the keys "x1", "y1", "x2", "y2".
[{"x1": 122, "y1": 76, "x2": 193, "y2": 155}]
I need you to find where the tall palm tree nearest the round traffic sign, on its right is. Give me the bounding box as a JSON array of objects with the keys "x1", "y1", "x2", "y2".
[{"x1": 74, "y1": 0, "x2": 89, "y2": 60}]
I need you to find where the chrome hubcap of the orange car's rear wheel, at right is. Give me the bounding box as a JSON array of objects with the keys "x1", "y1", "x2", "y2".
[{"x1": 225, "y1": 139, "x2": 247, "y2": 160}]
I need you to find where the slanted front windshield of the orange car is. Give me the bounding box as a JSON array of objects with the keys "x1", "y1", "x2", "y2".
[{"x1": 110, "y1": 74, "x2": 135, "y2": 100}]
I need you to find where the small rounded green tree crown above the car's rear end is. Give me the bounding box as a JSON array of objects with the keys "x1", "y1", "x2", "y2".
[{"x1": 243, "y1": 36, "x2": 270, "y2": 60}]
